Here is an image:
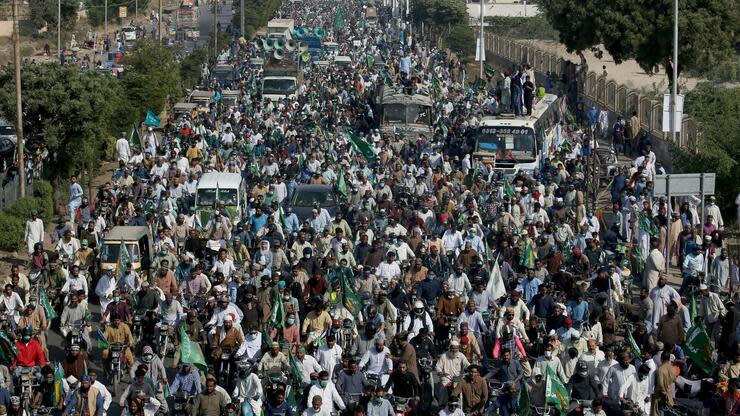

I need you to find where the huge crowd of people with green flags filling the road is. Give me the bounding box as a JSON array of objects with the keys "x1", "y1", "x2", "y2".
[{"x1": 5, "y1": 0, "x2": 740, "y2": 416}]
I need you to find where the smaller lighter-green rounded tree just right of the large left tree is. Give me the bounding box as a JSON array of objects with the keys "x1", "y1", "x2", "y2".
[{"x1": 119, "y1": 40, "x2": 182, "y2": 121}]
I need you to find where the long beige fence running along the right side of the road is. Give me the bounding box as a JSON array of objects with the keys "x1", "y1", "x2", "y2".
[{"x1": 485, "y1": 33, "x2": 701, "y2": 151}]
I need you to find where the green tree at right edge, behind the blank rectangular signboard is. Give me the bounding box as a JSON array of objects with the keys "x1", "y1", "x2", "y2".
[{"x1": 674, "y1": 83, "x2": 740, "y2": 216}]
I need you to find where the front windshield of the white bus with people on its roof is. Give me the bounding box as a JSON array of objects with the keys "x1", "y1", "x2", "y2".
[{"x1": 475, "y1": 126, "x2": 537, "y2": 162}]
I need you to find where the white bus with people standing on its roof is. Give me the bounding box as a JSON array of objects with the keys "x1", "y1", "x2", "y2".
[{"x1": 473, "y1": 94, "x2": 562, "y2": 177}]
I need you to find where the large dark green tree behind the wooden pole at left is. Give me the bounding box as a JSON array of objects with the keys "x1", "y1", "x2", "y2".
[{"x1": 0, "y1": 63, "x2": 131, "y2": 177}]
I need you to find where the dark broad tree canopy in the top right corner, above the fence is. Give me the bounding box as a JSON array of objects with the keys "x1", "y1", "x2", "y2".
[{"x1": 540, "y1": 0, "x2": 740, "y2": 72}]
